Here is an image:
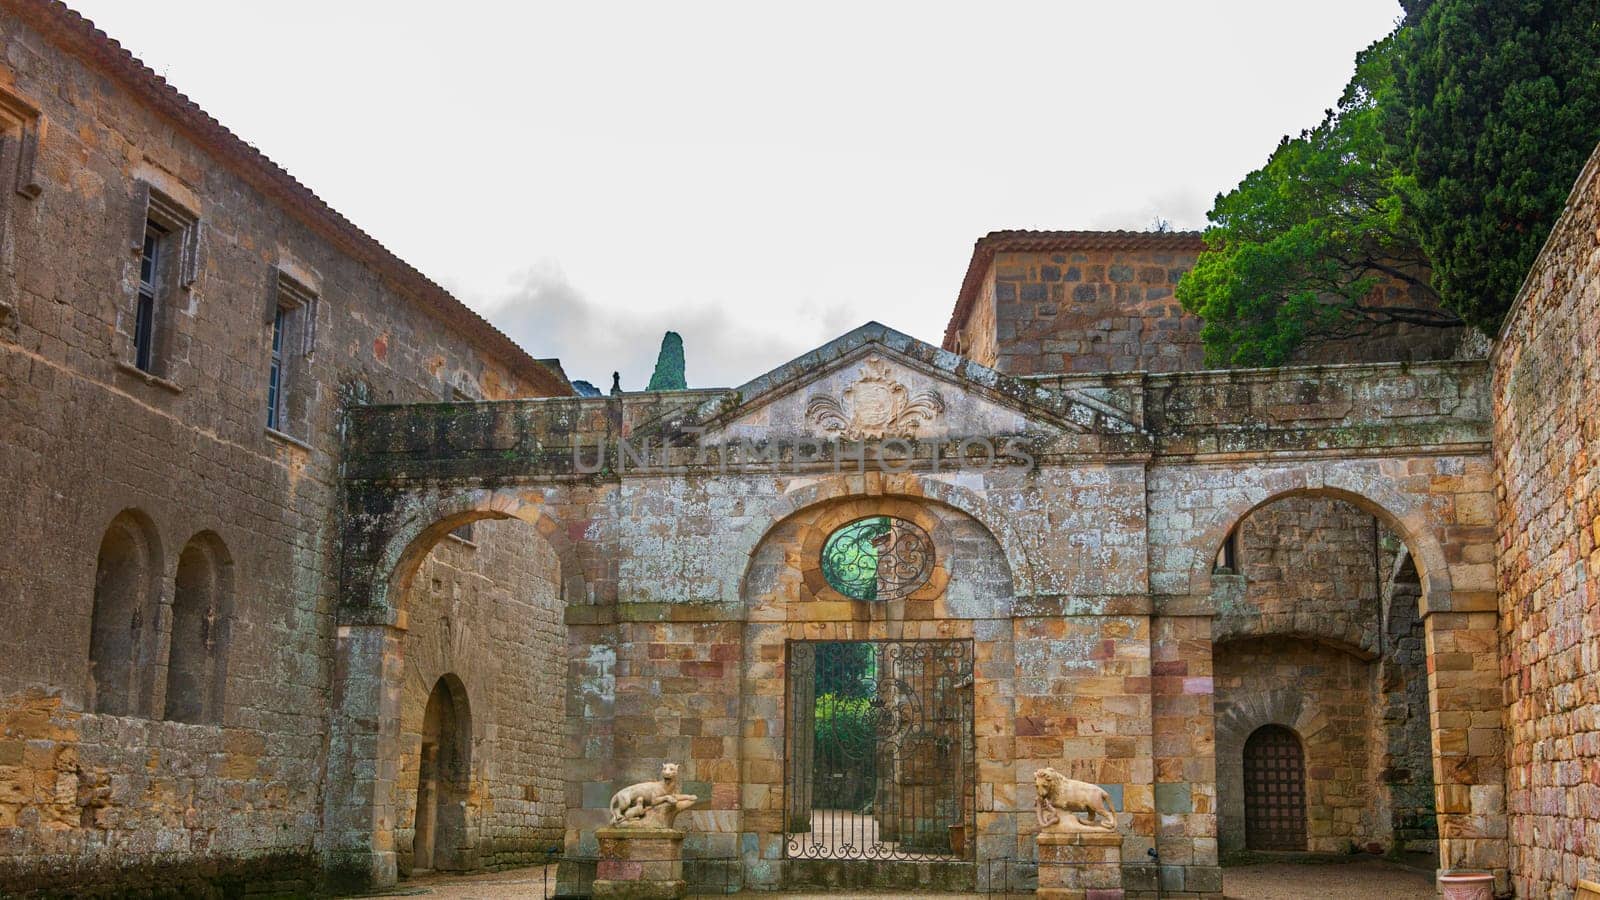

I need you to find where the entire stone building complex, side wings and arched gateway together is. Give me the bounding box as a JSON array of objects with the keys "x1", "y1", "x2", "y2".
[{"x1": 0, "y1": 0, "x2": 1600, "y2": 897}]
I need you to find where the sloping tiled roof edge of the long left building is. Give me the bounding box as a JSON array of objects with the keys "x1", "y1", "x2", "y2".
[{"x1": 0, "y1": 0, "x2": 573, "y2": 394}]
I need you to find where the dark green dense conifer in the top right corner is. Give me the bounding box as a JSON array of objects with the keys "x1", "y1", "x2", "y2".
[{"x1": 1387, "y1": 0, "x2": 1600, "y2": 335}]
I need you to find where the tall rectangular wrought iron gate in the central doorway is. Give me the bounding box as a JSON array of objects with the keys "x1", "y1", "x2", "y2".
[{"x1": 784, "y1": 641, "x2": 976, "y2": 860}]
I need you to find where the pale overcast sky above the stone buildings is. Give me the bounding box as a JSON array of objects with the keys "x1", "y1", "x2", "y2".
[{"x1": 67, "y1": 0, "x2": 1400, "y2": 389}]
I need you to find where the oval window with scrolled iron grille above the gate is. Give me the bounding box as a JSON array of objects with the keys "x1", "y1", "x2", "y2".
[{"x1": 822, "y1": 516, "x2": 933, "y2": 601}]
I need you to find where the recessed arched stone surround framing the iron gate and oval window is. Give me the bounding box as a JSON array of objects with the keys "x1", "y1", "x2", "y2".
[{"x1": 741, "y1": 490, "x2": 1032, "y2": 889}]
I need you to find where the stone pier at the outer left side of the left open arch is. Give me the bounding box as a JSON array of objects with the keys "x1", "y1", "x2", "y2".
[{"x1": 322, "y1": 625, "x2": 405, "y2": 890}]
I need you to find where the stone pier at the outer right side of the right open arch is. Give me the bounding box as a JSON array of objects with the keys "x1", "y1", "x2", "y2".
[{"x1": 1422, "y1": 596, "x2": 1510, "y2": 892}]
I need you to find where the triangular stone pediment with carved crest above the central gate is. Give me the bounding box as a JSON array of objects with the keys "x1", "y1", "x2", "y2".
[{"x1": 685, "y1": 322, "x2": 1138, "y2": 444}]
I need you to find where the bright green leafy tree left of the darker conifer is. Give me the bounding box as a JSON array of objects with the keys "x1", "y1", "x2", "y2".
[{"x1": 1178, "y1": 35, "x2": 1459, "y2": 365}]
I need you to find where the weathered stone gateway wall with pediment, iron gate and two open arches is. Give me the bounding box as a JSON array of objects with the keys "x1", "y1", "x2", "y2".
[{"x1": 328, "y1": 325, "x2": 1506, "y2": 895}]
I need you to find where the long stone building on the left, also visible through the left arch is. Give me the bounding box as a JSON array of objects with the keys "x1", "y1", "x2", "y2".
[{"x1": 0, "y1": 2, "x2": 571, "y2": 894}]
